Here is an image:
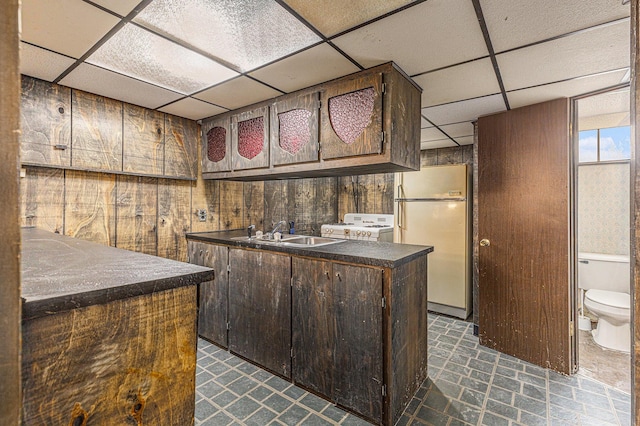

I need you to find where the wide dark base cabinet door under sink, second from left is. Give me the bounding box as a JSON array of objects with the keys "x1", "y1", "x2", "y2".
[{"x1": 229, "y1": 249, "x2": 291, "y2": 377}]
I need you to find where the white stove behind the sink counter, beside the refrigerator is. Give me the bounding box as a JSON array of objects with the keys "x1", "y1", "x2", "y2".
[{"x1": 320, "y1": 213, "x2": 393, "y2": 242}]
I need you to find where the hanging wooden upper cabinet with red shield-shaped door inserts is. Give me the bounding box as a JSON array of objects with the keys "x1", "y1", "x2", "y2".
[{"x1": 202, "y1": 62, "x2": 422, "y2": 180}]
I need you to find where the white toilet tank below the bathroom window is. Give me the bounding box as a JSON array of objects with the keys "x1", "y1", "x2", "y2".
[{"x1": 578, "y1": 253, "x2": 631, "y2": 294}]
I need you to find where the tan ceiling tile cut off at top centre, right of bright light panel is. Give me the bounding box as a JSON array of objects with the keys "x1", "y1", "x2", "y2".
[{"x1": 284, "y1": 0, "x2": 413, "y2": 37}]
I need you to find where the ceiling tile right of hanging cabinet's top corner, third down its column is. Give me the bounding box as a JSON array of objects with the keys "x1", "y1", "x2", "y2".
[{"x1": 413, "y1": 58, "x2": 500, "y2": 108}]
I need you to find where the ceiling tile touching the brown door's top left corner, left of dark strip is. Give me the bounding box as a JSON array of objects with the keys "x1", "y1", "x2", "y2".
[{"x1": 422, "y1": 95, "x2": 506, "y2": 125}]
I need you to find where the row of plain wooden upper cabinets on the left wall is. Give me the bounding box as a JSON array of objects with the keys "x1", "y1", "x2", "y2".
[{"x1": 20, "y1": 76, "x2": 199, "y2": 180}]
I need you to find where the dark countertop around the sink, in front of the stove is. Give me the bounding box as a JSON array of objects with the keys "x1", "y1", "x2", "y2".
[{"x1": 187, "y1": 230, "x2": 433, "y2": 268}]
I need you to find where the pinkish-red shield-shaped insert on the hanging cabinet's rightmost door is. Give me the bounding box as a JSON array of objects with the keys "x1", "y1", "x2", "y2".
[{"x1": 329, "y1": 87, "x2": 376, "y2": 145}]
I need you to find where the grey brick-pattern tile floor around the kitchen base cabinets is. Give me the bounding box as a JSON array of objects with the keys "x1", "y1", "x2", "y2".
[{"x1": 196, "y1": 314, "x2": 631, "y2": 426}]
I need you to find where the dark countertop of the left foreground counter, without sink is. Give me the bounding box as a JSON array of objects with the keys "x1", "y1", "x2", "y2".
[{"x1": 21, "y1": 228, "x2": 213, "y2": 319}]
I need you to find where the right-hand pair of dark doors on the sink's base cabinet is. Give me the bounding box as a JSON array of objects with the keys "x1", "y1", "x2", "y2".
[{"x1": 292, "y1": 258, "x2": 384, "y2": 419}]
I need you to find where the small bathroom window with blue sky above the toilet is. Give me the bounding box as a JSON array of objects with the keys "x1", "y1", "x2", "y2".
[{"x1": 578, "y1": 126, "x2": 631, "y2": 163}]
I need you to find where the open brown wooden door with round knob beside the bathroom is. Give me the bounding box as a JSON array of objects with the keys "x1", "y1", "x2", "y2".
[{"x1": 478, "y1": 99, "x2": 575, "y2": 374}]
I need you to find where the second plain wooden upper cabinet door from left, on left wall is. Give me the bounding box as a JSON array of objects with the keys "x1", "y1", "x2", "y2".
[{"x1": 71, "y1": 90, "x2": 122, "y2": 171}]
